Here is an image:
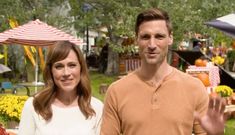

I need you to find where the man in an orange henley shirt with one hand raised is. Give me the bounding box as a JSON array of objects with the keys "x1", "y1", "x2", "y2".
[{"x1": 101, "y1": 9, "x2": 225, "y2": 135}]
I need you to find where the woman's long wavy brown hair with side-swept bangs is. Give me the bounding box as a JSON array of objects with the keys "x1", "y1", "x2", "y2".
[{"x1": 33, "y1": 41, "x2": 95, "y2": 120}]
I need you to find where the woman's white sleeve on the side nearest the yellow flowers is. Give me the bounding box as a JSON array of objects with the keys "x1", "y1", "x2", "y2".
[{"x1": 18, "y1": 97, "x2": 35, "y2": 135}]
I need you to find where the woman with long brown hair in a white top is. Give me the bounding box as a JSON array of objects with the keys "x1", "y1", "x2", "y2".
[{"x1": 18, "y1": 41, "x2": 103, "y2": 135}]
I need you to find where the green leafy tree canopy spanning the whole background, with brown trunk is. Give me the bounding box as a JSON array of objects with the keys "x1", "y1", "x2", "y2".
[{"x1": 0, "y1": 0, "x2": 235, "y2": 74}]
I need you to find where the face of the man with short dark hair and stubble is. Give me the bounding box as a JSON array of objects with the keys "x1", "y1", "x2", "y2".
[{"x1": 137, "y1": 20, "x2": 173, "y2": 65}]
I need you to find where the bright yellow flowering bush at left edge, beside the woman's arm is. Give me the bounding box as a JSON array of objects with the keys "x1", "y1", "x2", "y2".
[{"x1": 0, "y1": 95, "x2": 28, "y2": 122}]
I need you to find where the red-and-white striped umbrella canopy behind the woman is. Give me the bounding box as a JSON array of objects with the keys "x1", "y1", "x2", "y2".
[{"x1": 0, "y1": 19, "x2": 83, "y2": 46}]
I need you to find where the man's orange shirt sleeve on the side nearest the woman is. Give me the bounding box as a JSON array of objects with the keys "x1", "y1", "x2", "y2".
[{"x1": 101, "y1": 85, "x2": 121, "y2": 135}]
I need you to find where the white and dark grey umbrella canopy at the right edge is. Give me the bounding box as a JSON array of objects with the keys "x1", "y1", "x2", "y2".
[{"x1": 206, "y1": 13, "x2": 235, "y2": 38}]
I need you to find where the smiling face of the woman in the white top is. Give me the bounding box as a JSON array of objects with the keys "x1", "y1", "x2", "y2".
[{"x1": 52, "y1": 50, "x2": 81, "y2": 92}]
